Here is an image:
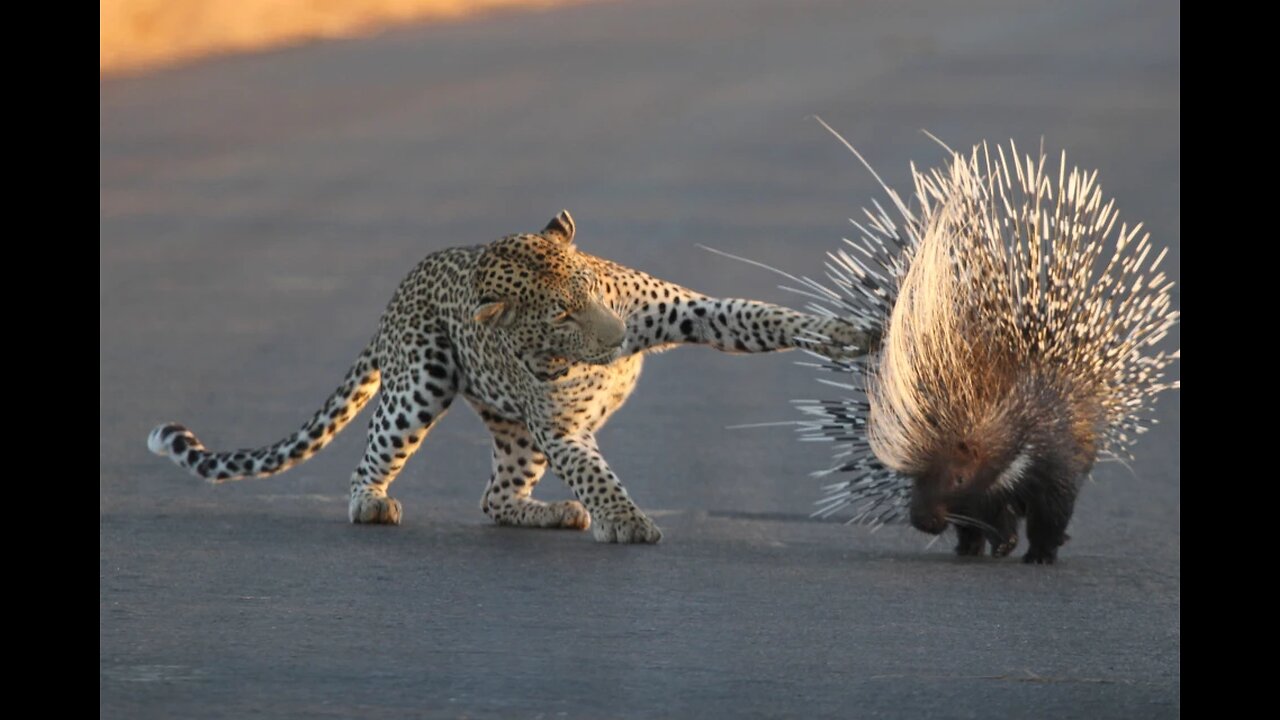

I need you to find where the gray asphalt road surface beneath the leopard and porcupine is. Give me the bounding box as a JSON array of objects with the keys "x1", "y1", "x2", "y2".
[{"x1": 99, "y1": 0, "x2": 1181, "y2": 719}]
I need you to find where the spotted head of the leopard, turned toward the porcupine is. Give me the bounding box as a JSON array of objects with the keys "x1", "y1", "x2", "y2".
[{"x1": 474, "y1": 210, "x2": 626, "y2": 380}]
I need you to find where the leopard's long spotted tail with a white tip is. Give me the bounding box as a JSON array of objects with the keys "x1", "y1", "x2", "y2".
[{"x1": 147, "y1": 343, "x2": 381, "y2": 483}]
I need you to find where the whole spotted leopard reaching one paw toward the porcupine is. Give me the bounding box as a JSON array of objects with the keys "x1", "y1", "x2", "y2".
[{"x1": 147, "y1": 210, "x2": 877, "y2": 543}]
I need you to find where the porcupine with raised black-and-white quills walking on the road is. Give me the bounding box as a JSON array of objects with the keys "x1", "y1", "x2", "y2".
[{"x1": 747, "y1": 119, "x2": 1179, "y2": 564}]
